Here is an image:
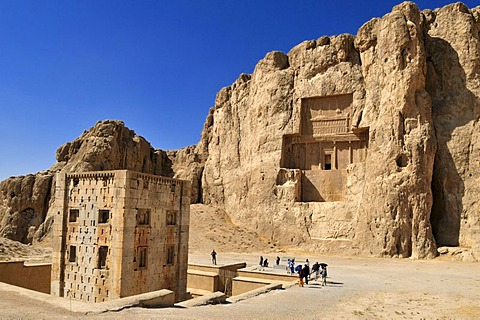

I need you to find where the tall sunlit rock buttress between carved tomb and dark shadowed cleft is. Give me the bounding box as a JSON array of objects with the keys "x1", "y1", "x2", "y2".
[{"x1": 354, "y1": 3, "x2": 436, "y2": 258}]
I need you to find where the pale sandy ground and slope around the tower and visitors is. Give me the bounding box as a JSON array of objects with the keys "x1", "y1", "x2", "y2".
[{"x1": 0, "y1": 206, "x2": 480, "y2": 320}]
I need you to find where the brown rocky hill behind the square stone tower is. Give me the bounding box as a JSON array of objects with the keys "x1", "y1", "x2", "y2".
[{"x1": 0, "y1": 120, "x2": 173, "y2": 243}]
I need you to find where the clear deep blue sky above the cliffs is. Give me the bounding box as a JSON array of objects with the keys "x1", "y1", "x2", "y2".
[{"x1": 0, "y1": 0, "x2": 479, "y2": 180}]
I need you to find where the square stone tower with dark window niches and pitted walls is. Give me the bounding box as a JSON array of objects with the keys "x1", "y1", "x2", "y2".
[{"x1": 51, "y1": 170, "x2": 190, "y2": 302}]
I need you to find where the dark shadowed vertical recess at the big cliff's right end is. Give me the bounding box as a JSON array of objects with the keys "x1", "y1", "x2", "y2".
[{"x1": 426, "y1": 36, "x2": 477, "y2": 246}]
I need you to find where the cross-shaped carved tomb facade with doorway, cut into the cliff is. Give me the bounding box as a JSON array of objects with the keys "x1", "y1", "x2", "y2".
[{"x1": 279, "y1": 94, "x2": 368, "y2": 202}]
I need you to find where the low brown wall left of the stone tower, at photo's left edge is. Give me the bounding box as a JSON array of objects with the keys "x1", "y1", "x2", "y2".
[{"x1": 0, "y1": 261, "x2": 52, "y2": 294}]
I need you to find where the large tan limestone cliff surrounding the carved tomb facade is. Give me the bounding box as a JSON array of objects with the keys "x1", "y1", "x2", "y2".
[{"x1": 197, "y1": 2, "x2": 480, "y2": 259}]
